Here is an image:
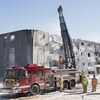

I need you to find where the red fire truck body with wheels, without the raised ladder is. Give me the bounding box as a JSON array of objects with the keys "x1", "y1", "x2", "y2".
[{"x1": 2, "y1": 64, "x2": 76, "y2": 95}]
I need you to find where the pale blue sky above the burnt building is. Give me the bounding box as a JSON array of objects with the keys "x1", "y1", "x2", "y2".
[{"x1": 0, "y1": 0, "x2": 100, "y2": 42}]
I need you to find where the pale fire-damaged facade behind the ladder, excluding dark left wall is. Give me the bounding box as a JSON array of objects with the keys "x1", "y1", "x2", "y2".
[{"x1": 33, "y1": 31, "x2": 100, "y2": 74}]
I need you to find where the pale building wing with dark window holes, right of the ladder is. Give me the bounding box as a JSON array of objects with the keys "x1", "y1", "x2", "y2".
[{"x1": 73, "y1": 39, "x2": 100, "y2": 75}]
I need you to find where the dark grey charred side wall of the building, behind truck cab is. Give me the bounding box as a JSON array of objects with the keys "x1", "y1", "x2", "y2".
[{"x1": 0, "y1": 30, "x2": 33, "y2": 77}]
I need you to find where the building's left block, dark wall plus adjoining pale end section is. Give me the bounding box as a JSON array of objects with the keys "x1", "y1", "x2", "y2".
[{"x1": 0, "y1": 30, "x2": 49, "y2": 77}]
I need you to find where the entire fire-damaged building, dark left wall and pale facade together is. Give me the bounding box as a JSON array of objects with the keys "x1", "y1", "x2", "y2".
[{"x1": 0, "y1": 29, "x2": 100, "y2": 77}]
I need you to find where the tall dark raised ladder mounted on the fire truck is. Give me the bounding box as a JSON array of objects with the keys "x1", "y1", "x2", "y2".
[{"x1": 58, "y1": 5, "x2": 76, "y2": 69}]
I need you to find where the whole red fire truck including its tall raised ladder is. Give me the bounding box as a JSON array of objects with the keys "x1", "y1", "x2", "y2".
[{"x1": 1, "y1": 6, "x2": 78, "y2": 95}]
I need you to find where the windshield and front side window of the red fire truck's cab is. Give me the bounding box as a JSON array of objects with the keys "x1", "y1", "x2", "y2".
[{"x1": 5, "y1": 70, "x2": 22, "y2": 78}]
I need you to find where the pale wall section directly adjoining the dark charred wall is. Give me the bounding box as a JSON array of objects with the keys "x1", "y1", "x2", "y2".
[{"x1": 32, "y1": 30, "x2": 49, "y2": 68}]
